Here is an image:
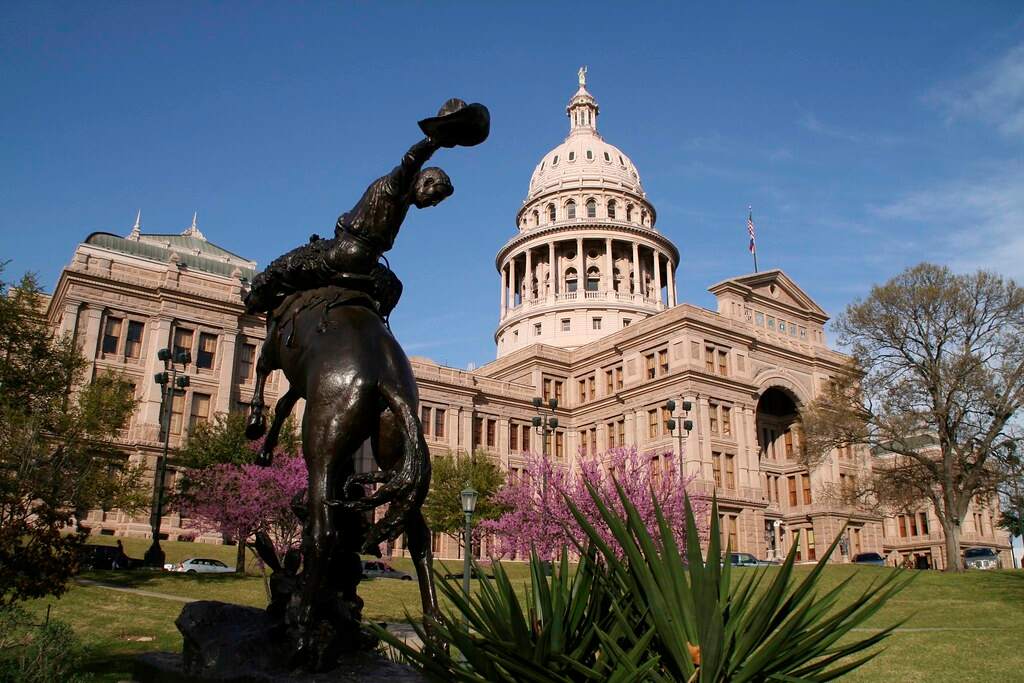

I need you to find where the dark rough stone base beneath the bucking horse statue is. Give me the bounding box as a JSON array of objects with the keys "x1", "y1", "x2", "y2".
[{"x1": 134, "y1": 600, "x2": 426, "y2": 683}]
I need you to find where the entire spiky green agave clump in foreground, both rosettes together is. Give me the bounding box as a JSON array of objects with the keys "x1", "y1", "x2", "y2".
[{"x1": 375, "y1": 486, "x2": 909, "y2": 683}]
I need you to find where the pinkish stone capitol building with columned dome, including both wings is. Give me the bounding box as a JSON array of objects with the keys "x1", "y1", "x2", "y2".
[{"x1": 49, "y1": 74, "x2": 1009, "y2": 566}]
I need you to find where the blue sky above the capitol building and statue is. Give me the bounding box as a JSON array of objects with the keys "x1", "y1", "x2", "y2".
[{"x1": 0, "y1": 2, "x2": 1024, "y2": 367}]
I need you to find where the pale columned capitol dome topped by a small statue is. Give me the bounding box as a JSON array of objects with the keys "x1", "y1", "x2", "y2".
[{"x1": 495, "y1": 69, "x2": 679, "y2": 357}]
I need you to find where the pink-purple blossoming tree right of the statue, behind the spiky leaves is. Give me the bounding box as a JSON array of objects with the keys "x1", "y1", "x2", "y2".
[{"x1": 483, "y1": 446, "x2": 708, "y2": 560}]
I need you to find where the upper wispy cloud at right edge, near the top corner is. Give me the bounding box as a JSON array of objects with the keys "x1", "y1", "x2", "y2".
[{"x1": 926, "y1": 43, "x2": 1024, "y2": 138}]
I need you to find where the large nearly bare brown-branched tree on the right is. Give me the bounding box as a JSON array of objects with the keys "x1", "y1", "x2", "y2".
[{"x1": 803, "y1": 263, "x2": 1024, "y2": 571}]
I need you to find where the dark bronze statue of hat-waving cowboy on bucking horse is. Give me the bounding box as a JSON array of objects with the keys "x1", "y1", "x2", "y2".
[{"x1": 246, "y1": 99, "x2": 490, "y2": 671}]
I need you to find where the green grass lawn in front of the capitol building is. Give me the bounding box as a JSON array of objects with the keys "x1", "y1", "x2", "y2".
[{"x1": 19, "y1": 539, "x2": 1024, "y2": 683}]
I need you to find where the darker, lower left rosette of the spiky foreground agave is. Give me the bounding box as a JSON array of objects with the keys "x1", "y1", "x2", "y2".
[{"x1": 370, "y1": 549, "x2": 657, "y2": 683}]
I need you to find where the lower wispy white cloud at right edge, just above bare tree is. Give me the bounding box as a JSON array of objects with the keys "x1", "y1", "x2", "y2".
[{"x1": 871, "y1": 162, "x2": 1024, "y2": 282}]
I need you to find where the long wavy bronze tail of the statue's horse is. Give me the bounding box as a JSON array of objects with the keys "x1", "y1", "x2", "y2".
[{"x1": 359, "y1": 383, "x2": 430, "y2": 552}]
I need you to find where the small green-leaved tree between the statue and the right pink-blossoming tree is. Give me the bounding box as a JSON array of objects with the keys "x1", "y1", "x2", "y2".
[{"x1": 423, "y1": 453, "x2": 505, "y2": 542}]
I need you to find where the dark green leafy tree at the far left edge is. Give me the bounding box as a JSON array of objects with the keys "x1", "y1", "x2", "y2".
[{"x1": 0, "y1": 266, "x2": 145, "y2": 603}]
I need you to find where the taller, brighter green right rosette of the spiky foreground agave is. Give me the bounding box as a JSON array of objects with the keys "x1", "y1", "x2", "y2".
[{"x1": 569, "y1": 488, "x2": 910, "y2": 683}]
